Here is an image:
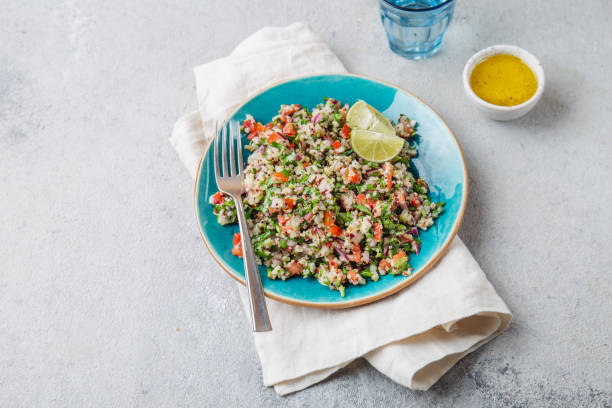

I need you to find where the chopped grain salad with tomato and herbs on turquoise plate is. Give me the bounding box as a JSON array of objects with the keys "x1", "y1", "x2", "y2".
[{"x1": 209, "y1": 98, "x2": 445, "y2": 296}]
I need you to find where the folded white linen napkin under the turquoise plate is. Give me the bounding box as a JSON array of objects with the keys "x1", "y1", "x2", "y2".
[{"x1": 170, "y1": 23, "x2": 512, "y2": 394}]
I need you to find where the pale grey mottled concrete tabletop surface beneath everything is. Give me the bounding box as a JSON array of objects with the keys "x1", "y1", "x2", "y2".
[{"x1": 0, "y1": 0, "x2": 612, "y2": 407}]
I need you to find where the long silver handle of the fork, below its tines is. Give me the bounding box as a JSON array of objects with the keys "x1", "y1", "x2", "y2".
[{"x1": 234, "y1": 196, "x2": 272, "y2": 332}]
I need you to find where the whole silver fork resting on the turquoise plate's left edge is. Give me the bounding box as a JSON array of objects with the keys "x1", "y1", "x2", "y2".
[{"x1": 214, "y1": 121, "x2": 272, "y2": 332}]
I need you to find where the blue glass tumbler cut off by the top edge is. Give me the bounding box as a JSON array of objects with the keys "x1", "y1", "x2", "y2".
[{"x1": 379, "y1": 0, "x2": 455, "y2": 59}]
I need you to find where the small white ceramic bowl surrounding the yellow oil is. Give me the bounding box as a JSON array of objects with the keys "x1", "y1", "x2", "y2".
[{"x1": 463, "y1": 45, "x2": 545, "y2": 120}]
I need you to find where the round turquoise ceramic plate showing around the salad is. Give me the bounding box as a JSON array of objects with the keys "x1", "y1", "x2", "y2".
[{"x1": 195, "y1": 74, "x2": 468, "y2": 308}]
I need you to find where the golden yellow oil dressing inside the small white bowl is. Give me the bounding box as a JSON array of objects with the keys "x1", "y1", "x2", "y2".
[{"x1": 470, "y1": 54, "x2": 538, "y2": 106}]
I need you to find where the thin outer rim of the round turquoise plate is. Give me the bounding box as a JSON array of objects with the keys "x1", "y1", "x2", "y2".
[{"x1": 193, "y1": 72, "x2": 469, "y2": 309}]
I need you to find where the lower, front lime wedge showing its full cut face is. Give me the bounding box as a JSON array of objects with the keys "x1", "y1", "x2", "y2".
[{"x1": 351, "y1": 129, "x2": 404, "y2": 163}]
